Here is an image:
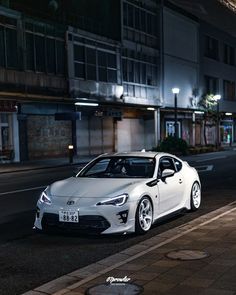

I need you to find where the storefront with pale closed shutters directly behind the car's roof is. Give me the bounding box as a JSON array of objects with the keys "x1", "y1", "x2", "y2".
[{"x1": 76, "y1": 106, "x2": 155, "y2": 155}]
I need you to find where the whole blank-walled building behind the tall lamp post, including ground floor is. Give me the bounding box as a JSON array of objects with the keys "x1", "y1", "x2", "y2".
[{"x1": 161, "y1": 6, "x2": 199, "y2": 145}]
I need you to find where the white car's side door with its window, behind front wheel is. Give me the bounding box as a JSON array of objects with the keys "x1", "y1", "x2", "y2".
[{"x1": 157, "y1": 156, "x2": 184, "y2": 215}]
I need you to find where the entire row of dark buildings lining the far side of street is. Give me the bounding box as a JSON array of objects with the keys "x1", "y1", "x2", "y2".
[{"x1": 0, "y1": 0, "x2": 236, "y2": 161}]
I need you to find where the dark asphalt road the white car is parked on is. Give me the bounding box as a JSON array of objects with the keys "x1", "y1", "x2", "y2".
[{"x1": 0, "y1": 151, "x2": 236, "y2": 295}]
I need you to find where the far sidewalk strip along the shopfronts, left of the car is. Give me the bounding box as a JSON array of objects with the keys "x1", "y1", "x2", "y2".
[{"x1": 0, "y1": 156, "x2": 96, "y2": 174}]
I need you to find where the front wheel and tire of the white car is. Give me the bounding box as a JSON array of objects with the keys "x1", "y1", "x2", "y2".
[{"x1": 135, "y1": 197, "x2": 153, "y2": 234}]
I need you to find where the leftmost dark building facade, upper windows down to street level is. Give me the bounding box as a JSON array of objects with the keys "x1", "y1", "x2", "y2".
[{"x1": 0, "y1": 7, "x2": 71, "y2": 161}]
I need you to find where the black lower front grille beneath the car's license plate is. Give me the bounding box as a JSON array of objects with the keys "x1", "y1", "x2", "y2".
[{"x1": 42, "y1": 213, "x2": 111, "y2": 233}]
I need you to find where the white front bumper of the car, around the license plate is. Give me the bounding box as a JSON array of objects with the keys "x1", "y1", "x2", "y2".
[{"x1": 34, "y1": 203, "x2": 135, "y2": 234}]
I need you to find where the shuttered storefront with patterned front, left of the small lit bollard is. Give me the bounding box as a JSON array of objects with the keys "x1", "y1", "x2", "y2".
[{"x1": 18, "y1": 103, "x2": 73, "y2": 161}]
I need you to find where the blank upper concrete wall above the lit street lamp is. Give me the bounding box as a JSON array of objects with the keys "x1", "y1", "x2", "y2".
[{"x1": 163, "y1": 8, "x2": 199, "y2": 108}]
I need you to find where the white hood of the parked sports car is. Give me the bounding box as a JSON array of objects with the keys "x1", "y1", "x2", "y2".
[{"x1": 50, "y1": 177, "x2": 144, "y2": 198}]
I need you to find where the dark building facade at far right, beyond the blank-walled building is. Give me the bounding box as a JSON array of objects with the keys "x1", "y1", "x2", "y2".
[{"x1": 200, "y1": 22, "x2": 236, "y2": 145}]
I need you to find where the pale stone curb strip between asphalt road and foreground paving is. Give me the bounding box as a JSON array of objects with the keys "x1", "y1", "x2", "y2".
[{"x1": 22, "y1": 201, "x2": 236, "y2": 295}]
